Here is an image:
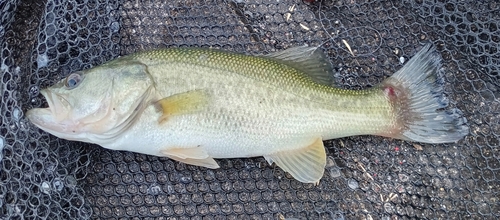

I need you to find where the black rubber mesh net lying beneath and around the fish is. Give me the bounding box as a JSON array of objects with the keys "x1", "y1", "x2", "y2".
[{"x1": 0, "y1": 0, "x2": 500, "y2": 219}]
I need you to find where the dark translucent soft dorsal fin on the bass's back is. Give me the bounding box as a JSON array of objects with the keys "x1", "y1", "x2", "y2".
[{"x1": 264, "y1": 45, "x2": 333, "y2": 85}]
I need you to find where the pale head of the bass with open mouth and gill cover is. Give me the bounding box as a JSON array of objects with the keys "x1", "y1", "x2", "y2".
[{"x1": 26, "y1": 62, "x2": 154, "y2": 145}]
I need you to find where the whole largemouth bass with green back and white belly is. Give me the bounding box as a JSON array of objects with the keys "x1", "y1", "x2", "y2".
[{"x1": 26, "y1": 44, "x2": 469, "y2": 184}]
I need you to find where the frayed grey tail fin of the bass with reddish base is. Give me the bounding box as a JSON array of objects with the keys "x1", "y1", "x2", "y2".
[{"x1": 381, "y1": 44, "x2": 469, "y2": 143}]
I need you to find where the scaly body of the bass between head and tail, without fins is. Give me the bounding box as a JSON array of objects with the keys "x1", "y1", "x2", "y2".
[{"x1": 107, "y1": 49, "x2": 392, "y2": 158}]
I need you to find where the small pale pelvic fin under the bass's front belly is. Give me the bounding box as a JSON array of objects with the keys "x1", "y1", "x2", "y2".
[{"x1": 160, "y1": 147, "x2": 219, "y2": 169}]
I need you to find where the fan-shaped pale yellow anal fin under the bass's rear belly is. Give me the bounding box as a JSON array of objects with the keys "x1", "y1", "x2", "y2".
[{"x1": 264, "y1": 138, "x2": 326, "y2": 185}]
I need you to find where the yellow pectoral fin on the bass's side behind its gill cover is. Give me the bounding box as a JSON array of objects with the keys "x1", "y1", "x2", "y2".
[{"x1": 156, "y1": 90, "x2": 208, "y2": 124}]
